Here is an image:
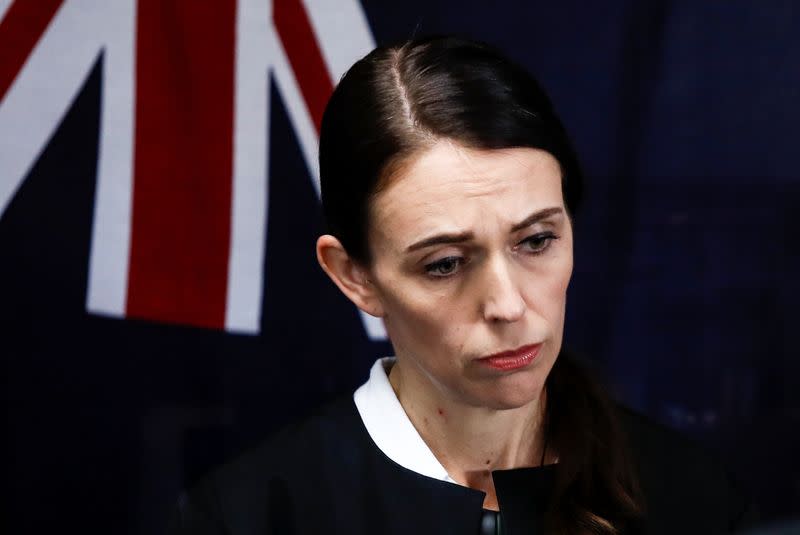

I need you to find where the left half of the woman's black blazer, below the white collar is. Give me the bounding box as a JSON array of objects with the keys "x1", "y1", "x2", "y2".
[{"x1": 169, "y1": 397, "x2": 483, "y2": 535}]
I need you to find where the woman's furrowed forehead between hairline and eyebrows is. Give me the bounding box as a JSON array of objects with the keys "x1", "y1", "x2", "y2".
[{"x1": 371, "y1": 141, "x2": 564, "y2": 249}]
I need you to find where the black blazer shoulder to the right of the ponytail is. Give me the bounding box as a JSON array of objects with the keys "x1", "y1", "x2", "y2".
[{"x1": 620, "y1": 408, "x2": 752, "y2": 533}]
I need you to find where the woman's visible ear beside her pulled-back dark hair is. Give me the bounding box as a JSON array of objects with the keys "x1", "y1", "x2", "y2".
[{"x1": 317, "y1": 234, "x2": 383, "y2": 318}]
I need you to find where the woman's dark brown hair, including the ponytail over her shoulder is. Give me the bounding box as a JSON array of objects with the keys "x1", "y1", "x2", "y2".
[{"x1": 319, "y1": 37, "x2": 642, "y2": 534}]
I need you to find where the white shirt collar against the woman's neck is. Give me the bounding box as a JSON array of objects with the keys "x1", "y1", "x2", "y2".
[{"x1": 353, "y1": 357, "x2": 456, "y2": 483}]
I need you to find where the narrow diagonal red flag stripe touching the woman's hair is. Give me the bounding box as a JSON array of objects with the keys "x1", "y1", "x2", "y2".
[{"x1": 272, "y1": 0, "x2": 333, "y2": 133}]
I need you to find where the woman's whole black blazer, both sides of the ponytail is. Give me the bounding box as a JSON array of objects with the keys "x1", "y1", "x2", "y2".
[{"x1": 170, "y1": 397, "x2": 749, "y2": 535}]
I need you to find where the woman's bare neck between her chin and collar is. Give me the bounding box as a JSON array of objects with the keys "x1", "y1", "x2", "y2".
[{"x1": 389, "y1": 361, "x2": 552, "y2": 510}]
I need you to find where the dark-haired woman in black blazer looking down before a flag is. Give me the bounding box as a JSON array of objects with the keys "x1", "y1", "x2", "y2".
[{"x1": 175, "y1": 38, "x2": 744, "y2": 534}]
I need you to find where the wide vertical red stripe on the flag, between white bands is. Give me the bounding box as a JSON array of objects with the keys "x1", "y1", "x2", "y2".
[{"x1": 127, "y1": 0, "x2": 236, "y2": 328}]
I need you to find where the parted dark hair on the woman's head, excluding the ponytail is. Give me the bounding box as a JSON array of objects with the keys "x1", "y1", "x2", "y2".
[{"x1": 319, "y1": 37, "x2": 583, "y2": 263}]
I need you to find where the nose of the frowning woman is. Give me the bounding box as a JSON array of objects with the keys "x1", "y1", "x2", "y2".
[{"x1": 481, "y1": 254, "x2": 525, "y2": 323}]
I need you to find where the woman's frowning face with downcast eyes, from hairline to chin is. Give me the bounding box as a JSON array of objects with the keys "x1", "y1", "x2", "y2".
[{"x1": 368, "y1": 141, "x2": 572, "y2": 409}]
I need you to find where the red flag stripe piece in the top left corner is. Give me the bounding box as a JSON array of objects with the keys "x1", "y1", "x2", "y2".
[{"x1": 0, "y1": 0, "x2": 63, "y2": 102}]
